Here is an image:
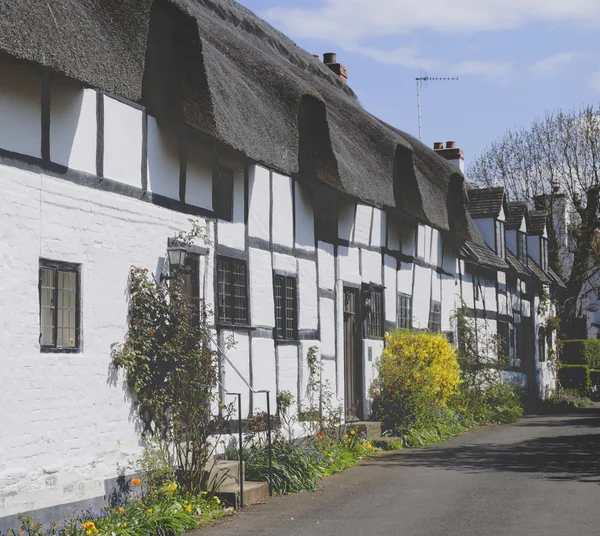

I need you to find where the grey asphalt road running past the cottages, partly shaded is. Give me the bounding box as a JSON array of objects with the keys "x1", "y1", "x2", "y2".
[{"x1": 199, "y1": 406, "x2": 600, "y2": 536}]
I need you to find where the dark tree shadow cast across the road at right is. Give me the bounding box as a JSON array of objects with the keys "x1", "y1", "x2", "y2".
[{"x1": 375, "y1": 408, "x2": 600, "y2": 483}]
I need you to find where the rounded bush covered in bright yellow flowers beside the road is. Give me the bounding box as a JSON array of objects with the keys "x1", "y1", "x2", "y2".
[{"x1": 371, "y1": 331, "x2": 460, "y2": 433}]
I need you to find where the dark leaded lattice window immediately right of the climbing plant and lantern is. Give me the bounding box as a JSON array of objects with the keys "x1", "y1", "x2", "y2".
[{"x1": 217, "y1": 257, "x2": 248, "y2": 326}]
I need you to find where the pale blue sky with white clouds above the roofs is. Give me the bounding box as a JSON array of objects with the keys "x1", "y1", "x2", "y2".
[{"x1": 240, "y1": 0, "x2": 600, "y2": 167}]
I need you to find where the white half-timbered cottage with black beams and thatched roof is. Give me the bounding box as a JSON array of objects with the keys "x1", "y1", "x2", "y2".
[{"x1": 0, "y1": 0, "x2": 564, "y2": 528}]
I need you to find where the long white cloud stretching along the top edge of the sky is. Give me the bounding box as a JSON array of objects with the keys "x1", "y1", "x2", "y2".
[{"x1": 266, "y1": 0, "x2": 600, "y2": 44}]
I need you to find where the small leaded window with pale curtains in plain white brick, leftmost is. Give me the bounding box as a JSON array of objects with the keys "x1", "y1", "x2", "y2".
[{"x1": 39, "y1": 260, "x2": 80, "y2": 352}]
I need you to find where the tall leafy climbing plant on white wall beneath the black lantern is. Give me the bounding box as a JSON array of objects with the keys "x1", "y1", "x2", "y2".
[{"x1": 112, "y1": 224, "x2": 227, "y2": 491}]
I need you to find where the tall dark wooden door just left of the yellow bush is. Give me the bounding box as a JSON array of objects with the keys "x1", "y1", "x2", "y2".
[{"x1": 344, "y1": 287, "x2": 363, "y2": 419}]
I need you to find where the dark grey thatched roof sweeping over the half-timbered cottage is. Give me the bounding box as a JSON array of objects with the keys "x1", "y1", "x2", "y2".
[{"x1": 0, "y1": 0, "x2": 477, "y2": 239}]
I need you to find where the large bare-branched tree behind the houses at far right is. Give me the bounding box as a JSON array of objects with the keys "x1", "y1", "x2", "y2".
[{"x1": 467, "y1": 106, "x2": 600, "y2": 334}]
